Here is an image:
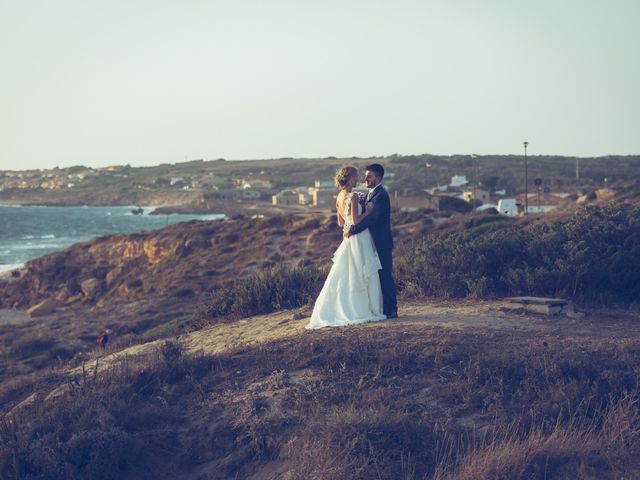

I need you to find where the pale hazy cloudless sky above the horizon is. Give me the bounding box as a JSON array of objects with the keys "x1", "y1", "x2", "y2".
[{"x1": 0, "y1": 0, "x2": 640, "y2": 169}]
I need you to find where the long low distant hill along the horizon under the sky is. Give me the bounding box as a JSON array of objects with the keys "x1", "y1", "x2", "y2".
[{"x1": 0, "y1": 154, "x2": 640, "y2": 213}]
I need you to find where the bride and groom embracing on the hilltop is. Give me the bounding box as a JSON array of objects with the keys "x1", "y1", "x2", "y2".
[{"x1": 307, "y1": 163, "x2": 398, "y2": 329}]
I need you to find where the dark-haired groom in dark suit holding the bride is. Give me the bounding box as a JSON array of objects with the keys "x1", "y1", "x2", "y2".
[{"x1": 344, "y1": 163, "x2": 398, "y2": 318}]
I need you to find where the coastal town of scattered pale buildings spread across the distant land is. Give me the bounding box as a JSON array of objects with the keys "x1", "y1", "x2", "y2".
[{"x1": 0, "y1": 155, "x2": 638, "y2": 216}]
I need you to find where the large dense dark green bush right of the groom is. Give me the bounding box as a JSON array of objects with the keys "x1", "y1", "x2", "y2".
[{"x1": 397, "y1": 204, "x2": 640, "y2": 303}]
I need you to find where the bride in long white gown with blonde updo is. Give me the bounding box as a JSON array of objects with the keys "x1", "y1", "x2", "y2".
[{"x1": 306, "y1": 167, "x2": 386, "y2": 329}]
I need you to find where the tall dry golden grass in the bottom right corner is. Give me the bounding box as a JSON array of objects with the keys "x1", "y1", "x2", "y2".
[{"x1": 434, "y1": 395, "x2": 640, "y2": 480}]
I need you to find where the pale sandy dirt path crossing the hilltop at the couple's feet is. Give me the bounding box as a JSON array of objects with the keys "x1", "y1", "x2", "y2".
[{"x1": 12, "y1": 300, "x2": 640, "y2": 406}]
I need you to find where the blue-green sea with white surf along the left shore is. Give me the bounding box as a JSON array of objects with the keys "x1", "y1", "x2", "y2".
[{"x1": 0, "y1": 205, "x2": 224, "y2": 272}]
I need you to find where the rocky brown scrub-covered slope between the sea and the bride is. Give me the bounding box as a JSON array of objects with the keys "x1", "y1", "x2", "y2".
[{"x1": 0, "y1": 214, "x2": 341, "y2": 312}]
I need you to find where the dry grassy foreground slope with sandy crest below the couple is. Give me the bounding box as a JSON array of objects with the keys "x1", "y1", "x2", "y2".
[{"x1": 0, "y1": 302, "x2": 640, "y2": 479}]
